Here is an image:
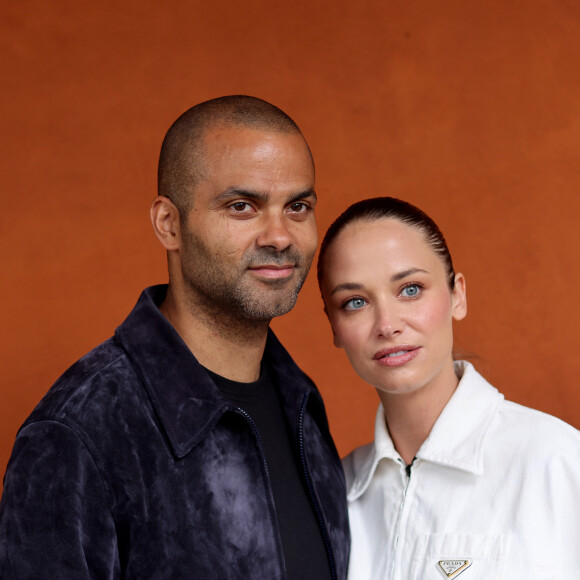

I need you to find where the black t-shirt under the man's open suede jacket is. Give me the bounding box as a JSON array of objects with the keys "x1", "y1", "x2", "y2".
[{"x1": 208, "y1": 366, "x2": 331, "y2": 580}]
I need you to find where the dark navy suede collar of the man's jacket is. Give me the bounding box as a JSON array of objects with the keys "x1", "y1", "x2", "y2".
[{"x1": 115, "y1": 285, "x2": 318, "y2": 457}]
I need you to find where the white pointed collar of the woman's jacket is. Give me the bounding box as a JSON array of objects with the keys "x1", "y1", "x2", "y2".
[{"x1": 348, "y1": 361, "x2": 503, "y2": 500}]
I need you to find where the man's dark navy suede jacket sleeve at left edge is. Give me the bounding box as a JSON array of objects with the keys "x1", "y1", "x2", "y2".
[{"x1": 0, "y1": 420, "x2": 119, "y2": 580}]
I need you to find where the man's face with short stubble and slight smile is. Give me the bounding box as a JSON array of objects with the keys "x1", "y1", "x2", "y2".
[{"x1": 180, "y1": 126, "x2": 317, "y2": 323}]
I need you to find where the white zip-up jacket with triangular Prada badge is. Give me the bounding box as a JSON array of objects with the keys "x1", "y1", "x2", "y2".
[{"x1": 343, "y1": 361, "x2": 580, "y2": 580}]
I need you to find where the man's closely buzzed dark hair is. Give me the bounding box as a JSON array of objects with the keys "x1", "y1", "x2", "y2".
[{"x1": 158, "y1": 95, "x2": 308, "y2": 219}]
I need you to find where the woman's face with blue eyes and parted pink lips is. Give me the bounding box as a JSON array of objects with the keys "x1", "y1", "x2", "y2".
[{"x1": 322, "y1": 218, "x2": 466, "y2": 402}]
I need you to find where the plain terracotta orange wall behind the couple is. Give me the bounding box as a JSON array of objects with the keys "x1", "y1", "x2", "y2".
[{"x1": 0, "y1": 0, "x2": 580, "y2": 484}]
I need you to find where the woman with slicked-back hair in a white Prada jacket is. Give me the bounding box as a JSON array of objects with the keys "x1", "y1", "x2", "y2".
[{"x1": 318, "y1": 197, "x2": 580, "y2": 580}]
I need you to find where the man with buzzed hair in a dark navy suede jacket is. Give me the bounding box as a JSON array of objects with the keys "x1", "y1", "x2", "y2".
[{"x1": 0, "y1": 96, "x2": 349, "y2": 580}]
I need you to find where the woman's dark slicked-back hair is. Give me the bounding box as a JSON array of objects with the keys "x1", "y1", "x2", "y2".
[{"x1": 317, "y1": 197, "x2": 455, "y2": 290}]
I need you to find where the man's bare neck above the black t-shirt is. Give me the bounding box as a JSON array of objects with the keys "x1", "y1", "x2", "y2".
[{"x1": 159, "y1": 289, "x2": 269, "y2": 383}]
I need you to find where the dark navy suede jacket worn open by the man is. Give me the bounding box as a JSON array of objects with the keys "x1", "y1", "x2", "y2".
[{"x1": 0, "y1": 286, "x2": 349, "y2": 580}]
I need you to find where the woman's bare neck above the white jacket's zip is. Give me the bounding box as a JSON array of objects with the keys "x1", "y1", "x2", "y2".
[{"x1": 377, "y1": 371, "x2": 459, "y2": 465}]
